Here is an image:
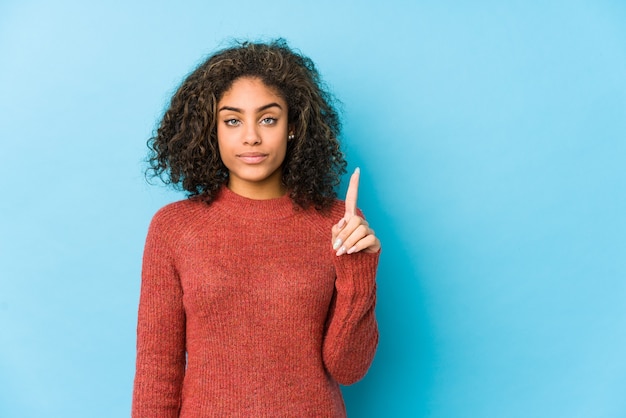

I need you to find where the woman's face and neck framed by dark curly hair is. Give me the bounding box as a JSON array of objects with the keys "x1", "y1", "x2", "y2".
[{"x1": 217, "y1": 77, "x2": 288, "y2": 199}]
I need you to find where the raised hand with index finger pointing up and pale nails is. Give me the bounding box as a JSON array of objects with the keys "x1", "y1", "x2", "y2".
[{"x1": 332, "y1": 168, "x2": 380, "y2": 256}]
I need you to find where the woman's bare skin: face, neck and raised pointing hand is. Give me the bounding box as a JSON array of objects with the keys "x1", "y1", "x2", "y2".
[{"x1": 217, "y1": 77, "x2": 380, "y2": 256}]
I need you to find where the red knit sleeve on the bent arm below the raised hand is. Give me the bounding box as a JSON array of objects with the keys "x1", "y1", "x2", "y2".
[{"x1": 322, "y1": 251, "x2": 380, "y2": 385}]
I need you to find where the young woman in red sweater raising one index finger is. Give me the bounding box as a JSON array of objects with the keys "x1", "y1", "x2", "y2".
[{"x1": 132, "y1": 40, "x2": 380, "y2": 417}]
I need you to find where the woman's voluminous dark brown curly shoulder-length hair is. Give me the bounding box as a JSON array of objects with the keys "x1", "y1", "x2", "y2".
[{"x1": 147, "y1": 39, "x2": 346, "y2": 210}]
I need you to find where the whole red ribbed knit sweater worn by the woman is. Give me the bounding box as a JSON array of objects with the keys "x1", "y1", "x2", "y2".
[{"x1": 132, "y1": 188, "x2": 378, "y2": 417}]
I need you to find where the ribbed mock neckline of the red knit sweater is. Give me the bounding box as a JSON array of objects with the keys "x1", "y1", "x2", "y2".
[{"x1": 214, "y1": 186, "x2": 294, "y2": 219}]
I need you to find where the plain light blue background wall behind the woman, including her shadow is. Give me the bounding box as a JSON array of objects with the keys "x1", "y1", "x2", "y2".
[{"x1": 0, "y1": 0, "x2": 626, "y2": 418}]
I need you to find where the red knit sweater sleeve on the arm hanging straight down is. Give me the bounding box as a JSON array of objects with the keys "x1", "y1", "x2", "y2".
[{"x1": 132, "y1": 213, "x2": 185, "y2": 417}]
